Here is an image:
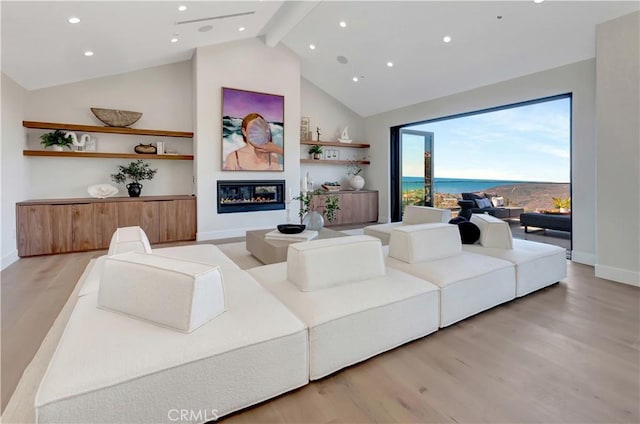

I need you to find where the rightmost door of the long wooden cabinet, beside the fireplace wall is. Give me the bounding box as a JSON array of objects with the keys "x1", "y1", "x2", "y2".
[{"x1": 158, "y1": 199, "x2": 196, "y2": 243}]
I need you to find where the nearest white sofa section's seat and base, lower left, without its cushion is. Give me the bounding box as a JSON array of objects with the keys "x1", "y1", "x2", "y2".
[{"x1": 35, "y1": 271, "x2": 308, "y2": 423}]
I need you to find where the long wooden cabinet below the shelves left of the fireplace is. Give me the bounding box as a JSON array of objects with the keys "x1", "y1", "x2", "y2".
[{"x1": 16, "y1": 196, "x2": 196, "y2": 256}]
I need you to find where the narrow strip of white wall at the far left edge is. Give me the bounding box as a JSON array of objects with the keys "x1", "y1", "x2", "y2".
[{"x1": 0, "y1": 73, "x2": 30, "y2": 269}]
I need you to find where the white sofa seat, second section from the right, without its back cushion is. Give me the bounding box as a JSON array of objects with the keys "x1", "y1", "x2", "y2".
[{"x1": 386, "y1": 252, "x2": 516, "y2": 327}]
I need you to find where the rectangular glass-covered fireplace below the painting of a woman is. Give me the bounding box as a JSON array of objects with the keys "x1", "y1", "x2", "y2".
[{"x1": 218, "y1": 180, "x2": 285, "y2": 213}]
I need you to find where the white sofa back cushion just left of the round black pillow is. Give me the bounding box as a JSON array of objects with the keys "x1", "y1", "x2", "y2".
[{"x1": 389, "y1": 223, "x2": 462, "y2": 263}]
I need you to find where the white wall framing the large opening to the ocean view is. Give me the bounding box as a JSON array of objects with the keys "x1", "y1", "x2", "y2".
[{"x1": 366, "y1": 59, "x2": 596, "y2": 265}]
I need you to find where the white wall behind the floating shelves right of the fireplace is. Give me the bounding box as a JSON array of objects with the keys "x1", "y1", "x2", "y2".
[{"x1": 300, "y1": 78, "x2": 369, "y2": 188}]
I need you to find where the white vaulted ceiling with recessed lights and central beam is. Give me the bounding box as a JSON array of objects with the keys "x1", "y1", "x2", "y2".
[{"x1": 2, "y1": 0, "x2": 640, "y2": 116}]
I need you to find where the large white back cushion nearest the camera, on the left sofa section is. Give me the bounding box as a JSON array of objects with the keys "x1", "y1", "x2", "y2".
[{"x1": 98, "y1": 252, "x2": 225, "y2": 333}]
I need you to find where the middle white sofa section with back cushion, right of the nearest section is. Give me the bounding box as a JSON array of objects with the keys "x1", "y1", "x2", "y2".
[{"x1": 249, "y1": 236, "x2": 439, "y2": 380}]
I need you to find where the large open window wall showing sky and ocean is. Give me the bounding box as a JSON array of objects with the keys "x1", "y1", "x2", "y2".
[{"x1": 391, "y1": 95, "x2": 571, "y2": 220}]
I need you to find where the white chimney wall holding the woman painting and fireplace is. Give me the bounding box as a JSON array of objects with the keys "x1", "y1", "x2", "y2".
[{"x1": 194, "y1": 38, "x2": 300, "y2": 240}]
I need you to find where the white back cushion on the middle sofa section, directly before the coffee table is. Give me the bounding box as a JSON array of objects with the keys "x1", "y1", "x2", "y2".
[{"x1": 287, "y1": 236, "x2": 385, "y2": 291}]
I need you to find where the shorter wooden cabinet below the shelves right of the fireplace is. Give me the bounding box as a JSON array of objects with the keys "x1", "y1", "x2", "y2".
[{"x1": 313, "y1": 190, "x2": 378, "y2": 227}]
